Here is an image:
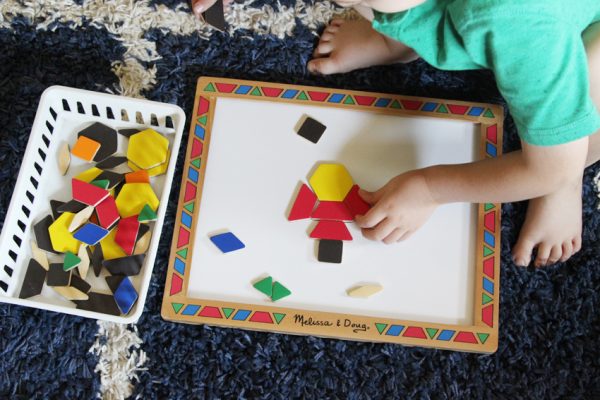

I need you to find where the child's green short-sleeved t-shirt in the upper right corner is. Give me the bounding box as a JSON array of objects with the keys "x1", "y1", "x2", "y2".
[{"x1": 373, "y1": 0, "x2": 600, "y2": 146}]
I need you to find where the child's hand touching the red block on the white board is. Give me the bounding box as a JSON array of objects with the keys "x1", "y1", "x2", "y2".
[{"x1": 356, "y1": 170, "x2": 438, "y2": 244}]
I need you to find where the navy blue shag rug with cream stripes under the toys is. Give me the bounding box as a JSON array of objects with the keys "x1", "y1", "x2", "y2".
[{"x1": 0, "y1": 0, "x2": 600, "y2": 399}]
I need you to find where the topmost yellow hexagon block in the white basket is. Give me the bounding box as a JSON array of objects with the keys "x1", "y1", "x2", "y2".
[{"x1": 127, "y1": 129, "x2": 169, "y2": 169}]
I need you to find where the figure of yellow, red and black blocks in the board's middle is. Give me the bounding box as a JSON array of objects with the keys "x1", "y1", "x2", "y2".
[{"x1": 288, "y1": 164, "x2": 370, "y2": 263}]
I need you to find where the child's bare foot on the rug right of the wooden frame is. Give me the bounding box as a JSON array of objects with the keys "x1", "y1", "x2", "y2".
[{"x1": 513, "y1": 185, "x2": 581, "y2": 267}]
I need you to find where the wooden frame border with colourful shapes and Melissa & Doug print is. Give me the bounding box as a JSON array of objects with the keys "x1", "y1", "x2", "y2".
[{"x1": 161, "y1": 77, "x2": 504, "y2": 353}]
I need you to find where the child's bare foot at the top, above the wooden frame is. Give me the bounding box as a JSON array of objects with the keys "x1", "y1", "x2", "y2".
[{"x1": 308, "y1": 19, "x2": 417, "y2": 75}]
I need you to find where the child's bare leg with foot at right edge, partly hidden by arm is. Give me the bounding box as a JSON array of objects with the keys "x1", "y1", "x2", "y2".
[{"x1": 513, "y1": 23, "x2": 600, "y2": 266}]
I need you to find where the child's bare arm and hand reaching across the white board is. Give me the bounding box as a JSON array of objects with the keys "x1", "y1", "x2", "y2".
[{"x1": 356, "y1": 137, "x2": 588, "y2": 243}]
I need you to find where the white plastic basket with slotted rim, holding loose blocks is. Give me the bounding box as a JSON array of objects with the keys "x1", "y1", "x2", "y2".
[{"x1": 0, "y1": 86, "x2": 185, "y2": 323}]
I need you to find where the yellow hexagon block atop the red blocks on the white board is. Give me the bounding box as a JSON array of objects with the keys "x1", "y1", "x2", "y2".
[{"x1": 309, "y1": 164, "x2": 354, "y2": 201}]
